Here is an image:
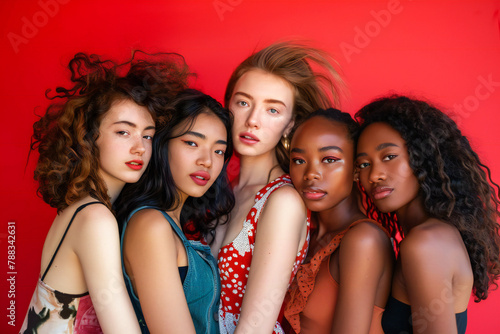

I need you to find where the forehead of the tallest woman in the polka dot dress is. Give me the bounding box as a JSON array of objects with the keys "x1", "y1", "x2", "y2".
[{"x1": 233, "y1": 69, "x2": 293, "y2": 101}]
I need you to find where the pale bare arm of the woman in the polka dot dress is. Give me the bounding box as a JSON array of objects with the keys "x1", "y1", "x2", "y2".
[{"x1": 235, "y1": 186, "x2": 306, "y2": 333}]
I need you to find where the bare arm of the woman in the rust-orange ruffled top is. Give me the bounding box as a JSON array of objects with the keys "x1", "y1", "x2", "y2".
[{"x1": 330, "y1": 223, "x2": 394, "y2": 334}]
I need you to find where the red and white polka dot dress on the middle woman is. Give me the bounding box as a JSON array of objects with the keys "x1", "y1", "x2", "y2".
[{"x1": 218, "y1": 174, "x2": 310, "y2": 334}]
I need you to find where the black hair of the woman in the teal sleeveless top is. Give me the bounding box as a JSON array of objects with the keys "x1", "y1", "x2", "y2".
[{"x1": 115, "y1": 89, "x2": 234, "y2": 240}]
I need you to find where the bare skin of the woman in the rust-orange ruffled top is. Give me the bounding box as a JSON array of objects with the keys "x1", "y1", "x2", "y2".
[{"x1": 290, "y1": 116, "x2": 394, "y2": 333}]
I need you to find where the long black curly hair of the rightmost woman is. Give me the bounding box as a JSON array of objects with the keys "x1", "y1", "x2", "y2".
[{"x1": 355, "y1": 96, "x2": 500, "y2": 302}]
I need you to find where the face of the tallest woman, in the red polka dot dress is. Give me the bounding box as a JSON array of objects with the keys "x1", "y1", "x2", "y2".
[{"x1": 229, "y1": 69, "x2": 294, "y2": 156}]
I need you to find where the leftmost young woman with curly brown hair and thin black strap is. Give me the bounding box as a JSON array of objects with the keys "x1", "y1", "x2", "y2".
[{"x1": 21, "y1": 53, "x2": 186, "y2": 334}]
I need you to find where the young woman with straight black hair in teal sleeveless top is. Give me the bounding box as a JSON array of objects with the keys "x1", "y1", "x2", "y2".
[{"x1": 119, "y1": 90, "x2": 234, "y2": 333}]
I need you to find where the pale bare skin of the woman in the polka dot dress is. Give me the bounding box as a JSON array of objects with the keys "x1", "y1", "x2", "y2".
[{"x1": 213, "y1": 69, "x2": 307, "y2": 333}]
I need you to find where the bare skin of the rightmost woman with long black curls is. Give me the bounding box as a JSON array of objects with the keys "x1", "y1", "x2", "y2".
[{"x1": 357, "y1": 122, "x2": 473, "y2": 333}]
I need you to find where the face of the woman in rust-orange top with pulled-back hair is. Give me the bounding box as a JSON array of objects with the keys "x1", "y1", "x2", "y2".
[{"x1": 290, "y1": 116, "x2": 354, "y2": 212}]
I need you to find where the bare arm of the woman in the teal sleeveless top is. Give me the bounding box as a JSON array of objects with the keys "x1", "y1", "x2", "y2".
[{"x1": 123, "y1": 210, "x2": 195, "y2": 334}]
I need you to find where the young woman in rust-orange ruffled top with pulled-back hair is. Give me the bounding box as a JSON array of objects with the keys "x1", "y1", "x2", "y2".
[{"x1": 285, "y1": 109, "x2": 394, "y2": 334}]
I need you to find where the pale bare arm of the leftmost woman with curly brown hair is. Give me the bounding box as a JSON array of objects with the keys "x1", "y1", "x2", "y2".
[{"x1": 74, "y1": 205, "x2": 141, "y2": 333}]
